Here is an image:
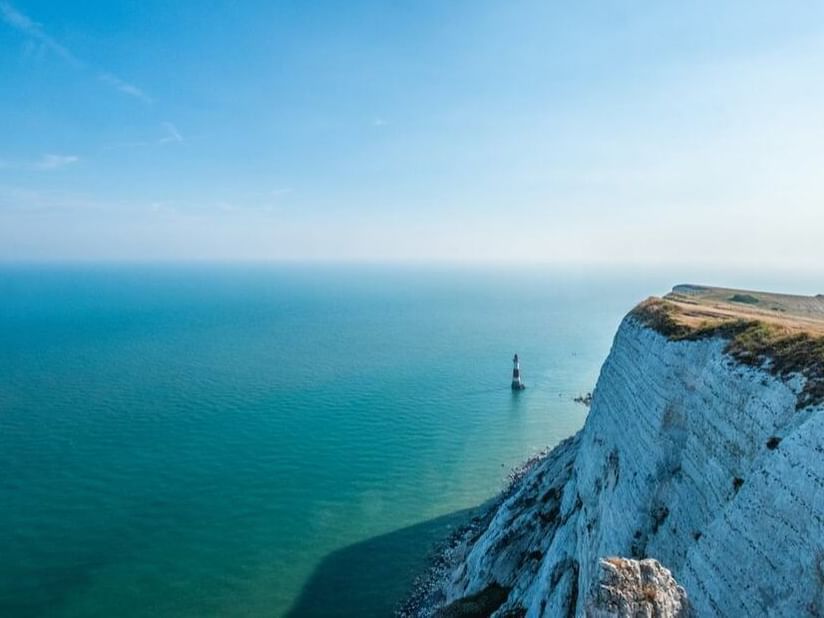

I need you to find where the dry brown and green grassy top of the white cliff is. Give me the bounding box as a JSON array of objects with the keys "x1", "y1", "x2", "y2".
[{"x1": 631, "y1": 285, "x2": 824, "y2": 408}]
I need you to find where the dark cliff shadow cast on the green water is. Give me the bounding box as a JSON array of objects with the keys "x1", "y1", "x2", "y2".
[{"x1": 286, "y1": 508, "x2": 479, "y2": 618}]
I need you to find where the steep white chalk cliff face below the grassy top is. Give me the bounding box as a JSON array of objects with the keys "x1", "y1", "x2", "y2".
[{"x1": 424, "y1": 314, "x2": 824, "y2": 617}]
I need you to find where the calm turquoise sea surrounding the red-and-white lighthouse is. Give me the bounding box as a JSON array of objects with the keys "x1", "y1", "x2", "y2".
[{"x1": 0, "y1": 266, "x2": 696, "y2": 617}]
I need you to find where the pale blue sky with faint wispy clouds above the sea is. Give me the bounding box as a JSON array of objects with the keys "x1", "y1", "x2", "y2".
[{"x1": 0, "y1": 0, "x2": 824, "y2": 272}]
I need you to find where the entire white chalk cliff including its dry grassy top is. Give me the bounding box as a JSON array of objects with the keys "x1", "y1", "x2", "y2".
[{"x1": 405, "y1": 286, "x2": 824, "y2": 618}]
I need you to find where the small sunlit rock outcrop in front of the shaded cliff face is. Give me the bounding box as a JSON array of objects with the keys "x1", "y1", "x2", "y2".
[{"x1": 585, "y1": 558, "x2": 690, "y2": 618}]
